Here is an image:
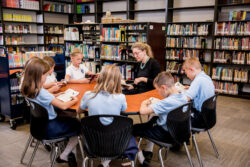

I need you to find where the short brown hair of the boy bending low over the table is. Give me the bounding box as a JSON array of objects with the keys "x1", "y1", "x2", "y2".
[{"x1": 154, "y1": 71, "x2": 174, "y2": 88}]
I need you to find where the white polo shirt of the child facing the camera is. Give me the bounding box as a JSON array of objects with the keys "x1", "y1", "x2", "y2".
[{"x1": 66, "y1": 64, "x2": 89, "y2": 80}]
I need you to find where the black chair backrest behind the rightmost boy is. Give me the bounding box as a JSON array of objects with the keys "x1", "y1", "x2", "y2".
[{"x1": 201, "y1": 94, "x2": 218, "y2": 129}]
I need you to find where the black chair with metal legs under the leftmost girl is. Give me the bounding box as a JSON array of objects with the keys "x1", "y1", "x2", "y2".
[{"x1": 21, "y1": 101, "x2": 81, "y2": 167}]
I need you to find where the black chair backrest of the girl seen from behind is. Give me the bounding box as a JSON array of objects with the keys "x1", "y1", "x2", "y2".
[{"x1": 81, "y1": 115, "x2": 133, "y2": 159}]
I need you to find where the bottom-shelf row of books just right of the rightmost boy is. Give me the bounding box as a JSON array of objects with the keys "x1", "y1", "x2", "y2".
[{"x1": 214, "y1": 81, "x2": 239, "y2": 95}]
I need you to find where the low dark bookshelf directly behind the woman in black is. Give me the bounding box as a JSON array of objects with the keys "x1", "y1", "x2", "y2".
[{"x1": 100, "y1": 22, "x2": 165, "y2": 80}]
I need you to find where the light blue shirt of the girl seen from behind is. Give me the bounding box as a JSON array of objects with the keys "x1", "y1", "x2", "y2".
[{"x1": 80, "y1": 91, "x2": 127, "y2": 125}]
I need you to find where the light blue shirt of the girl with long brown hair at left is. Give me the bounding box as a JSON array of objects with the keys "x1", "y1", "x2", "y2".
[{"x1": 29, "y1": 87, "x2": 57, "y2": 120}]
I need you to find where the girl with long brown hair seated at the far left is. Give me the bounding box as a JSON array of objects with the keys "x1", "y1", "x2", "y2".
[{"x1": 21, "y1": 58, "x2": 80, "y2": 166}]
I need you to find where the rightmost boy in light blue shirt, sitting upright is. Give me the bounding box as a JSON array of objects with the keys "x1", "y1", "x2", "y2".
[{"x1": 183, "y1": 57, "x2": 214, "y2": 127}]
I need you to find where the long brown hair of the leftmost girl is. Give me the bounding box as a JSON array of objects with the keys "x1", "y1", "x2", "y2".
[{"x1": 21, "y1": 58, "x2": 50, "y2": 98}]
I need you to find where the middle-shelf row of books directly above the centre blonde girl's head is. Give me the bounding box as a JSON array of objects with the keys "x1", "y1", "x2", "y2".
[{"x1": 101, "y1": 44, "x2": 128, "y2": 60}]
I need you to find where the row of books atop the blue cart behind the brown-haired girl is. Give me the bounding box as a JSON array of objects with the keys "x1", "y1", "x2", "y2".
[{"x1": 8, "y1": 51, "x2": 55, "y2": 68}]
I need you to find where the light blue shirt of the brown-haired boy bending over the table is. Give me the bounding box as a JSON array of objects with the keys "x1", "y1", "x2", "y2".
[{"x1": 150, "y1": 93, "x2": 188, "y2": 131}]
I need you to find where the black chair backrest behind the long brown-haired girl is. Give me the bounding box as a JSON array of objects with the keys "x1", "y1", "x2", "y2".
[{"x1": 29, "y1": 101, "x2": 49, "y2": 140}]
